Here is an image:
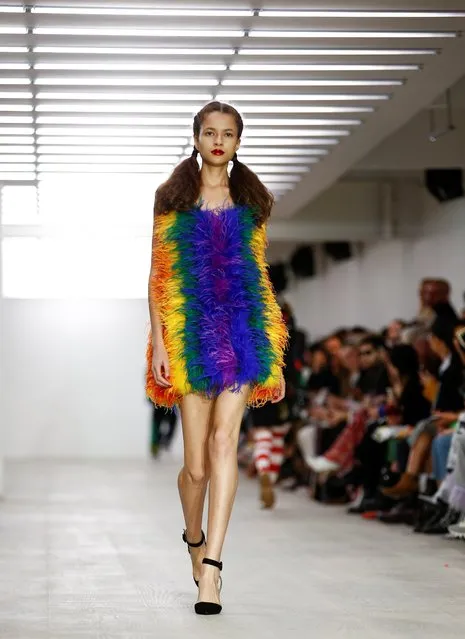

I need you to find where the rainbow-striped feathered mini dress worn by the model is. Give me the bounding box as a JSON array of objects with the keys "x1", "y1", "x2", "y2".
[{"x1": 146, "y1": 206, "x2": 289, "y2": 408}]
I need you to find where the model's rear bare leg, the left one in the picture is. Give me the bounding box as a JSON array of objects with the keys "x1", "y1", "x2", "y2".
[{"x1": 178, "y1": 393, "x2": 214, "y2": 580}]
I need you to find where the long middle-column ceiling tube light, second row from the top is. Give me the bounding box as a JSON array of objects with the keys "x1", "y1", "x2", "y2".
[{"x1": 34, "y1": 27, "x2": 244, "y2": 38}]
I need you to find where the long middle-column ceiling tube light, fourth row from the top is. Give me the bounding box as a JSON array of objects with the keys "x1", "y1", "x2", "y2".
[{"x1": 35, "y1": 62, "x2": 226, "y2": 71}]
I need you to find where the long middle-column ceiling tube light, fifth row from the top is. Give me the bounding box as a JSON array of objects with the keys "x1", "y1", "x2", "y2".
[{"x1": 35, "y1": 76, "x2": 218, "y2": 87}]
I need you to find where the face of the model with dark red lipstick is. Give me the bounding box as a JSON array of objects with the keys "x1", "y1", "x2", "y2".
[{"x1": 194, "y1": 111, "x2": 241, "y2": 166}]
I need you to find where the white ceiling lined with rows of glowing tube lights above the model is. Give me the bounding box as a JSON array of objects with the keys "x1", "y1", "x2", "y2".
[{"x1": 0, "y1": 0, "x2": 465, "y2": 208}]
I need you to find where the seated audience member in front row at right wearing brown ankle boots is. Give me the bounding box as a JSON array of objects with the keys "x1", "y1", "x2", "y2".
[{"x1": 383, "y1": 317, "x2": 463, "y2": 498}]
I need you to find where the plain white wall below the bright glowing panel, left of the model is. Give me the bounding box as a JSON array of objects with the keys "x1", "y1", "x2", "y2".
[{"x1": 2, "y1": 299, "x2": 150, "y2": 458}]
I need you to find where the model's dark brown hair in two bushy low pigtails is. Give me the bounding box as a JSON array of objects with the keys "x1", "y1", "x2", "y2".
[{"x1": 155, "y1": 101, "x2": 274, "y2": 226}]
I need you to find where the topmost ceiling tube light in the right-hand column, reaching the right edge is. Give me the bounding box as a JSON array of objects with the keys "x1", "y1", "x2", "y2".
[{"x1": 259, "y1": 9, "x2": 465, "y2": 18}]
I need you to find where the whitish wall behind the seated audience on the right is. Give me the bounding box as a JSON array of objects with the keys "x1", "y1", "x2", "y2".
[{"x1": 286, "y1": 197, "x2": 465, "y2": 338}]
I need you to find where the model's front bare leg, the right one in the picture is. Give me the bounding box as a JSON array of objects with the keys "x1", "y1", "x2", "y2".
[{"x1": 199, "y1": 385, "x2": 250, "y2": 603}]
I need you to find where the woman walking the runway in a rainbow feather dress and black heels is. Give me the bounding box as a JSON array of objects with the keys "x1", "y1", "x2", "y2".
[{"x1": 146, "y1": 102, "x2": 289, "y2": 615}]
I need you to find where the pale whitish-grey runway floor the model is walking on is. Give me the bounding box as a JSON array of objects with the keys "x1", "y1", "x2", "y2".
[{"x1": 0, "y1": 459, "x2": 465, "y2": 639}]
